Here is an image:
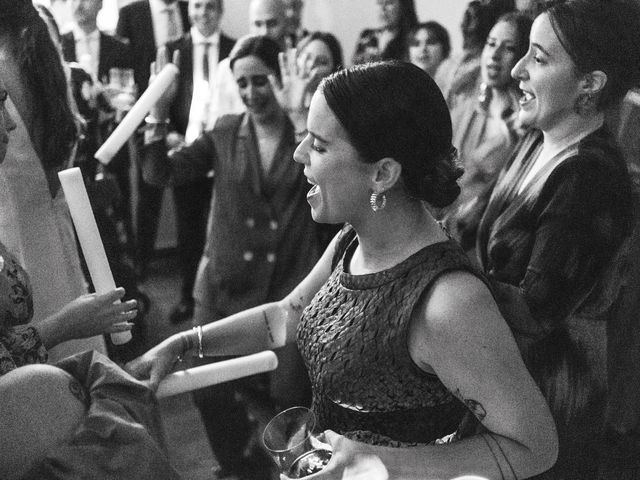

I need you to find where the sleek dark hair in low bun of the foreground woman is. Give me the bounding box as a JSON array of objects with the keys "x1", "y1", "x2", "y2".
[{"x1": 318, "y1": 61, "x2": 462, "y2": 207}]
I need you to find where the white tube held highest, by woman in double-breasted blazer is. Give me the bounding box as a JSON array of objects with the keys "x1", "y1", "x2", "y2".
[{"x1": 94, "y1": 63, "x2": 179, "y2": 165}]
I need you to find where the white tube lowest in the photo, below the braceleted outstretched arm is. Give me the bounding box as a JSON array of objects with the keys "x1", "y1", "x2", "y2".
[{"x1": 156, "y1": 350, "x2": 278, "y2": 398}]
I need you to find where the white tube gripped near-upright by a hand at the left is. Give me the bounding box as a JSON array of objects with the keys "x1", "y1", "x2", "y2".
[{"x1": 58, "y1": 167, "x2": 131, "y2": 345}]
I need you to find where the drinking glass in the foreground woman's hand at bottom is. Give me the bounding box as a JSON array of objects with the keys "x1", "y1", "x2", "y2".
[{"x1": 262, "y1": 407, "x2": 331, "y2": 478}]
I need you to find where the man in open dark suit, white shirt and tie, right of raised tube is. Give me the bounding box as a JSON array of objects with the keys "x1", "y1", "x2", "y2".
[{"x1": 162, "y1": 0, "x2": 235, "y2": 323}]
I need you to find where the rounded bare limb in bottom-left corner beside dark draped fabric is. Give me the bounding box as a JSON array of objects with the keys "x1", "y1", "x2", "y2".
[{"x1": 0, "y1": 364, "x2": 88, "y2": 480}]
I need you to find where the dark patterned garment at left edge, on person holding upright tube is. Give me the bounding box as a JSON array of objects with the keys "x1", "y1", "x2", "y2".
[{"x1": 0, "y1": 243, "x2": 47, "y2": 375}]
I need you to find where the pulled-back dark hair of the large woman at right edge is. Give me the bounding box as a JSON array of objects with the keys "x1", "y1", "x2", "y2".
[{"x1": 543, "y1": 0, "x2": 640, "y2": 110}]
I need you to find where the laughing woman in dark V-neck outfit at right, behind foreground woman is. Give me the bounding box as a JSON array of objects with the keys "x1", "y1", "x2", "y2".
[{"x1": 477, "y1": 0, "x2": 640, "y2": 480}]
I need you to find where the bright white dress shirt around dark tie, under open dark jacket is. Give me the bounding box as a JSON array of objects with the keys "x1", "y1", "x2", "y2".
[{"x1": 185, "y1": 27, "x2": 220, "y2": 144}]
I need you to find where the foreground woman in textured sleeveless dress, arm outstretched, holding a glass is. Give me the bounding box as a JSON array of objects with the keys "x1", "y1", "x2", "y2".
[{"x1": 127, "y1": 62, "x2": 556, "y2": 479}]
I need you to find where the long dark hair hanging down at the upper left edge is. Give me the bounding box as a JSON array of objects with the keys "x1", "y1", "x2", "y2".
[{"x1": 0, "y1": 0, "x2": 77, "y2": 172}]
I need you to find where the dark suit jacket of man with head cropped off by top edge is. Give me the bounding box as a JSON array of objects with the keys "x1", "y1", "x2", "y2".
[{"x1": 116, "y1": 0, "x2": 190, "y2": 94}]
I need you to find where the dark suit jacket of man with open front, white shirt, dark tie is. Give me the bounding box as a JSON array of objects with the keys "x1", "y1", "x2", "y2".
[{"x1": 167, "y1": 33, "x2": 235, "y2": 135}]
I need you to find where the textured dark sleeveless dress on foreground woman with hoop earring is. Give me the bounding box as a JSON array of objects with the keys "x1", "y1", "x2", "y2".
[{"x1": 297, "y1": 227, "x2": 473, "y2": 446}]
